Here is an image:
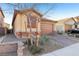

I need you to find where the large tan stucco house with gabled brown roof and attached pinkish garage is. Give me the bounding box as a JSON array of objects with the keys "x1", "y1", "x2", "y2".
[{"x1": 12, "y1": 9, "x2": 54, "y2": 38}]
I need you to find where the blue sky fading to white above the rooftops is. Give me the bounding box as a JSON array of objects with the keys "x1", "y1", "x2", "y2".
[{"x1": 0, "y1": 3, "x2": 79, "y2": 24}]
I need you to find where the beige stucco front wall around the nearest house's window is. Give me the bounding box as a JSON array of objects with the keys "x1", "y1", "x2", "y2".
[{"x1": 14, "y1": 13, "x2": 40, "y2": 32}]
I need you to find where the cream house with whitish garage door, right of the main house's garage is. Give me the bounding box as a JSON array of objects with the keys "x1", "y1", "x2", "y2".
[{"x1": 55, "y1": 18, "x2": 75, "y2": 32}]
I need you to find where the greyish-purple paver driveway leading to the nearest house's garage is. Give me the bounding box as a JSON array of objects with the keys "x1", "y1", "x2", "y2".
[{"x1": 49, "y1": 34, "x2": 79, "y2": 47}]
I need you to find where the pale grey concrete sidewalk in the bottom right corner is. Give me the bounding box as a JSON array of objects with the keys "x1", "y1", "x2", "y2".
[{"x1": 42, "y1": 43, "x2": 79, "y2": 56}]
